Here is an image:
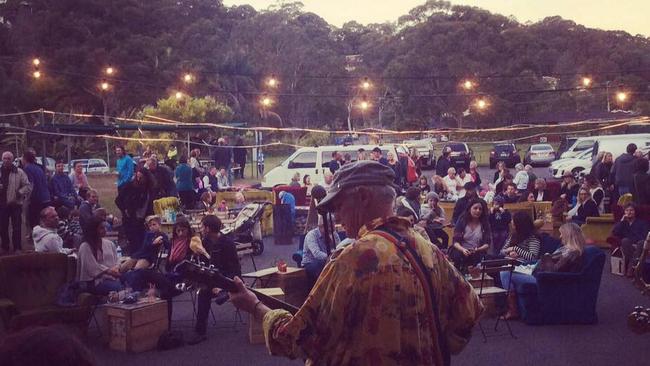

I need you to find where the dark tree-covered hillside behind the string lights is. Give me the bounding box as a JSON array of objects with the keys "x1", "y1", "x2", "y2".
[{"x1": 0, "y1": 0, "x2": 650, "y2": 128}]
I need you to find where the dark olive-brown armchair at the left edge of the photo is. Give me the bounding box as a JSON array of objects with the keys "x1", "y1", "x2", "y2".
[{"x1": 0, "y1": 253, "x2": 95, "y2": 334}]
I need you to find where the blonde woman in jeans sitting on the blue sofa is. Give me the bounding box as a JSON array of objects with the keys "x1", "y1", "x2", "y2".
[{"x1": 500, "y1": 222, "x2": 585, "y2": 319}]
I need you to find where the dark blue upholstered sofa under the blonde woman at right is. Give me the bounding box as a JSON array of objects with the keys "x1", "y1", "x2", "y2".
[{"x1": 517, "y1": 246, "x2": 606, "y2": 325}]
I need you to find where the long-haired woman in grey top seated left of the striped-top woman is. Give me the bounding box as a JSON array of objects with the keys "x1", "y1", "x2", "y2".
[{"x1": 449, "y1": 198, "x2": 492, "y2": 272}]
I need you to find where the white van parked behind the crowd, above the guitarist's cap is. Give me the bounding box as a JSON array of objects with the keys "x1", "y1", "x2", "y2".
[{"x1": 262, "y1": 144, "x2": 408, "y2": 187}]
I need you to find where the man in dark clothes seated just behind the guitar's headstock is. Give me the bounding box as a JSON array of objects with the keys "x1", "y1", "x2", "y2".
[{"x1": 187, "y1": 215, "x2": 241, "y2": 344}]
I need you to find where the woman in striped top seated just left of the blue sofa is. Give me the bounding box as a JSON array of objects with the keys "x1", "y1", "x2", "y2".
[{"x1": 500, "y1": 211, "x2": 541, "y2": 262}]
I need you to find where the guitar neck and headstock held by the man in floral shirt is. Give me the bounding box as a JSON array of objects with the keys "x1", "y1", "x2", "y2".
[{"x1": 174, "y1": 260, "x2": 298, "y2": 314}]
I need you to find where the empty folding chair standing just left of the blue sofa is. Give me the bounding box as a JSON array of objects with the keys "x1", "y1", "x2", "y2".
[{"x1": 474, "y1": 259, "x2": 519, "y2": 342}]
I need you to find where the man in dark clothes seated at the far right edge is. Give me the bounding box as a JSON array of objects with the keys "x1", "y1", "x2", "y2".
[{"x1": 612, "y1": 203, "x2": 650, "y2": 277}]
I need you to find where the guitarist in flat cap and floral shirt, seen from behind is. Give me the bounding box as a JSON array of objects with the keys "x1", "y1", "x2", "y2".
[{"x1": 230, "y1": 161, "x2": 483, "y2": 366}]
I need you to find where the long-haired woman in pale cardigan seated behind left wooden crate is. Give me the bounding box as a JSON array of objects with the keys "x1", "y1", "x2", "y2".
[{"x1": 79, "y1": 216, "x2": 124, "y2": 296}]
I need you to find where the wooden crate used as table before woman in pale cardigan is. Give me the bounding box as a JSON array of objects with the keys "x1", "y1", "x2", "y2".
[{"x1": 105, "y1": 300, "x2": 169, "y2": 352}]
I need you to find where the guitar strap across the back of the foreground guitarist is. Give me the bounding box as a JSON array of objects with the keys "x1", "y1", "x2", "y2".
[{"x1": 372, "y1": 226, "x2": 451, "y2": 366}]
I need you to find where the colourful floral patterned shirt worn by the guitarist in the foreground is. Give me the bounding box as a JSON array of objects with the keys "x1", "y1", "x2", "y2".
[{"x1": 264, "y1": 217, "x2": 483, "y2": 366}]
